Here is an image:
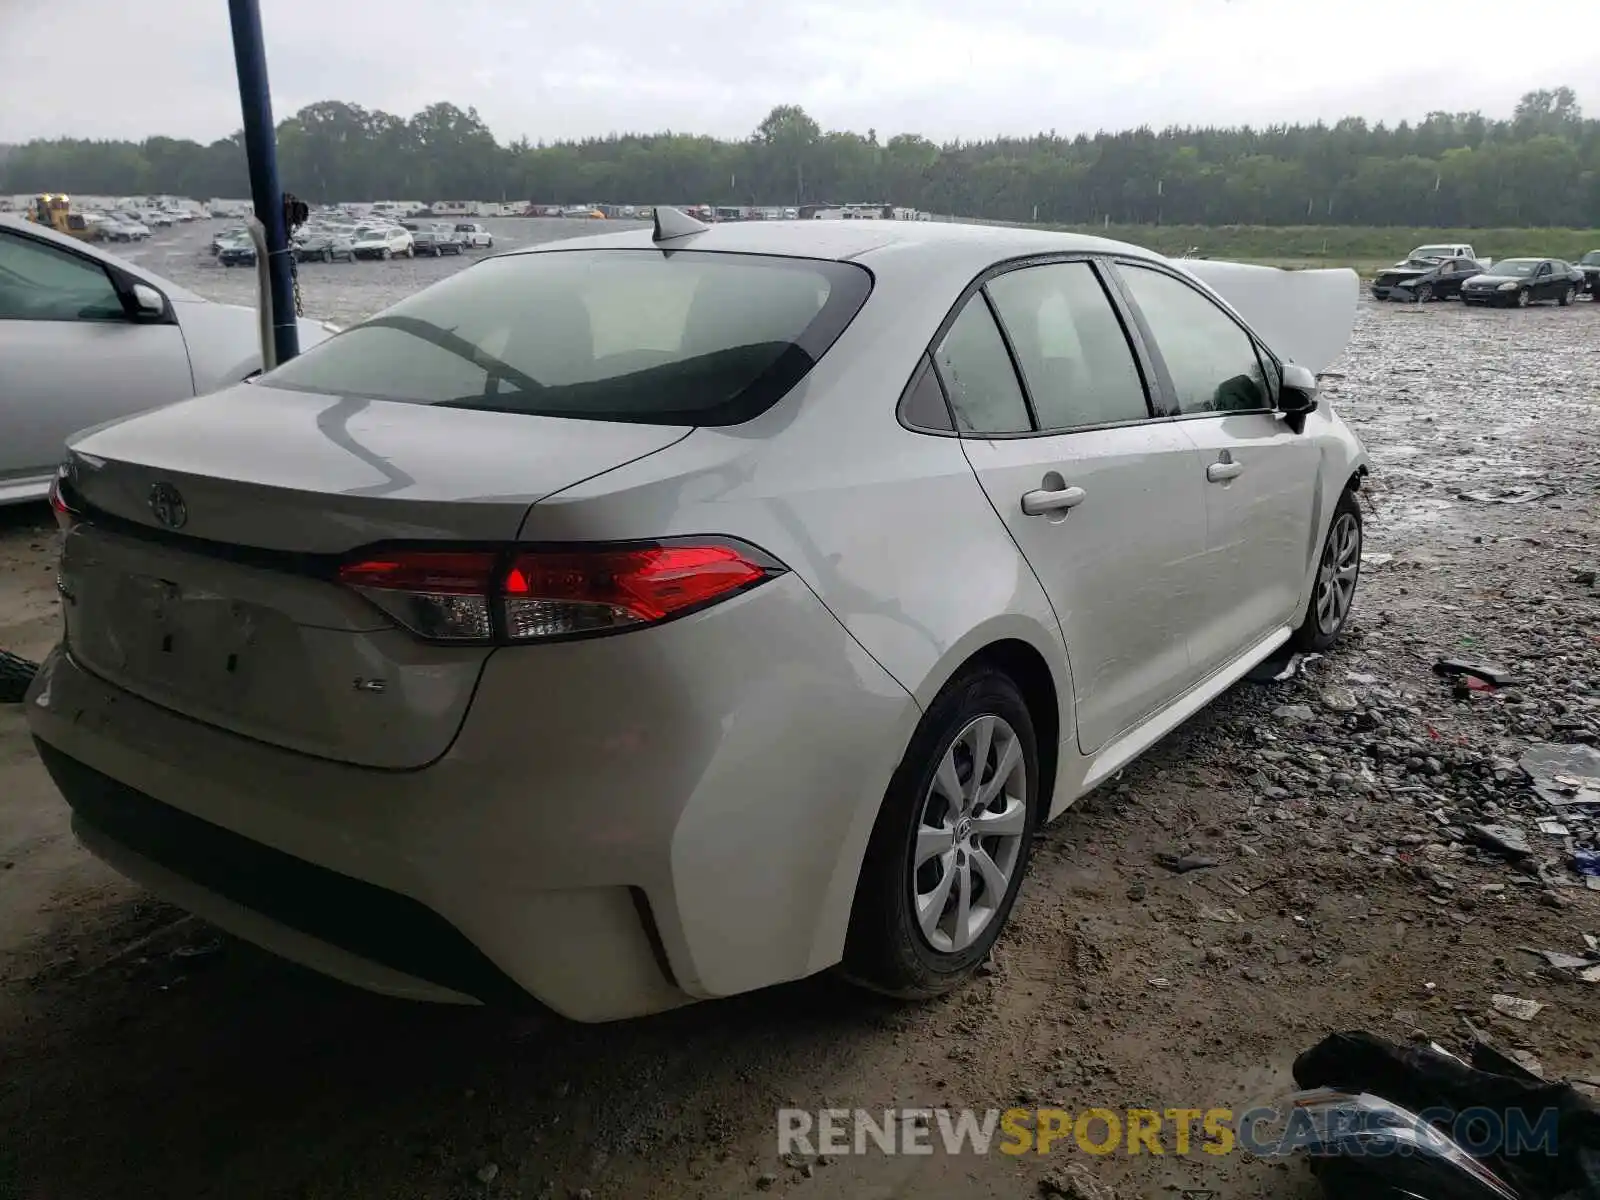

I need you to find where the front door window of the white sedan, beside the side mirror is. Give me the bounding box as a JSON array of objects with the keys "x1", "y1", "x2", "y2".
[{"x1": 1122, "y1": 264, "x2": 1270, "y2": 413}]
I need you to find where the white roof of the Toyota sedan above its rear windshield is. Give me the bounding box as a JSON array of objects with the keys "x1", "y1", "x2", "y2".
[{"x1": 509, "y1": 221, "x2": 1162, "y2": 272}]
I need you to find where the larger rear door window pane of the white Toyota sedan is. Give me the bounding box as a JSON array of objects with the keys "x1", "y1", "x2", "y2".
[{"x1": 989, "y1": 262, "x2": 1150, "y2": 429}]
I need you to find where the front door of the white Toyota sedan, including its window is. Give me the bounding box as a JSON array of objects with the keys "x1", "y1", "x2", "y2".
[{"x1": 1115, "y1": 261, "x2": 1318, "y2": 675}]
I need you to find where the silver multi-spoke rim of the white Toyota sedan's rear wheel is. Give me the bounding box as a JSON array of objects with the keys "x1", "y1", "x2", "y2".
[{"x1": 910, "y1": 714, "x2": 1027, "y2": 954}]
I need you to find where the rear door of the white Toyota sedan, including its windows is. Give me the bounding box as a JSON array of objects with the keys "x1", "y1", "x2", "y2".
[{"x1": 934, "y1": 259, "x2": 1205, "y2": 752}]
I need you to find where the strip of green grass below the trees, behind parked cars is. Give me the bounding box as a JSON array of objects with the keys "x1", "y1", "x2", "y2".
[{"x1": 1030, "y1": 226, "x2": 1600, "y2": 274}]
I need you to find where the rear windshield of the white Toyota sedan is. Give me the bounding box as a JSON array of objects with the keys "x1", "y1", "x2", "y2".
[{"x1": 261, "y1": 250, "x2": 872, "y2": 426}]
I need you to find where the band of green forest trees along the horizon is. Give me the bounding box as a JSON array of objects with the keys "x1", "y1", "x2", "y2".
[{"x1": 0, "y1": 86, "x2": 1600, "y2": 229}]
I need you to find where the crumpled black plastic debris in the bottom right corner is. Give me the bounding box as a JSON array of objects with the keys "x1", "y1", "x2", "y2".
[{"x1": 1294, "y1": 1032, "x2": 1600, "y2": 1200}]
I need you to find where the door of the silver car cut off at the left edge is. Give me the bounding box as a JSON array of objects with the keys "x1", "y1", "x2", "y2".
[{"x1": 0, "y1": 229, "x2": 194, "y2": 499}]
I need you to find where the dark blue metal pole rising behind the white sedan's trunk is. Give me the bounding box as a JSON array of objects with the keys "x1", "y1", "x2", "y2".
[{"x1": 227, "y1": 0, "x2": 299, "y2": 363}]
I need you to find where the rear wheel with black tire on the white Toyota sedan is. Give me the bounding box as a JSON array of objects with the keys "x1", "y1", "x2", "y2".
[{"x1": 843, "y1": 666, "x2": 1042, "y2": 1000}]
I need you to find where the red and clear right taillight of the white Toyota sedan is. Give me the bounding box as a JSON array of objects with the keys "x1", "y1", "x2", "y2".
[{"x1": 338, "y1": 539, "x2": 784, "y2": 643}]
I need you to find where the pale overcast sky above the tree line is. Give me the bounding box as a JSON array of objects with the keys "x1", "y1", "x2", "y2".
[{"x1": 0, "y1": 0, "x2": 1600, "y2": 142}]
